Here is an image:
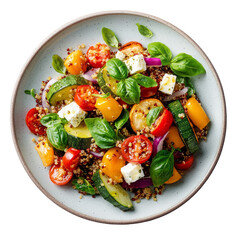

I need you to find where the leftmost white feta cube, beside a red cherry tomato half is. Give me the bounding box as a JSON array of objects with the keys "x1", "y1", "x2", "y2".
[{"x1": 58, "y1": 102, "x2": 87, "y2": 127}]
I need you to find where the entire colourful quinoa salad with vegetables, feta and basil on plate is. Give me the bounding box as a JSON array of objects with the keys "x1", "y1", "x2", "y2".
[{"x1": 25, "y1": 23, "x2": 210, "y2": 211}]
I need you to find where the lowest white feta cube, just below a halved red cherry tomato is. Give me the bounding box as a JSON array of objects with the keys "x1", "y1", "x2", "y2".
[{"x1": 121, "y1": 163, "x2": 144, "y2": 184}]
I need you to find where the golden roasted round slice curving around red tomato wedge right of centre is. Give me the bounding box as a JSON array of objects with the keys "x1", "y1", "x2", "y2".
[{"x1": 129, "y1": 98, "x2": 164, "y2": 132}]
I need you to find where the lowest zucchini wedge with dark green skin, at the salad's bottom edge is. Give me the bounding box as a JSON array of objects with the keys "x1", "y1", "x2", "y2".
[{"x1": 93, "y1": 171, "x2": 133, "y2": 211}]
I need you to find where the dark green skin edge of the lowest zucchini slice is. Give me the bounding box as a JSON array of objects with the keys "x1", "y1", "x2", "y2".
[{"x1": 92, "y1": 170, "x2": 134, "y2": 211}]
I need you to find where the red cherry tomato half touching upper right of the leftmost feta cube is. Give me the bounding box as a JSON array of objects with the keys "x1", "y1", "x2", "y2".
[{"x1": 74, "y1": 85, "x2": 99, "y2": 111}]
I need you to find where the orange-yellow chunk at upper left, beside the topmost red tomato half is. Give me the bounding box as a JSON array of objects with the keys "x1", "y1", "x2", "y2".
[{"x1": 64, "y1": 50, "x2": 87, "y2": 75}]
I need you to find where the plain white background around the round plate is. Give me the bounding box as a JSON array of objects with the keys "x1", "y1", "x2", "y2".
[{"x1": 0, "y1": 0, "x2": 240, "y2": 240}]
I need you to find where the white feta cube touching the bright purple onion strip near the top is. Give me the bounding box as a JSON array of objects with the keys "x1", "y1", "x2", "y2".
[{"x1": 124, "y1": 54, "x2": 147, "y2": 74}]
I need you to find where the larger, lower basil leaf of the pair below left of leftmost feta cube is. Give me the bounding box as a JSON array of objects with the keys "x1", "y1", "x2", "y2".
[{"x1": 47, "y1": 124, "x2": 68, "y2": 151}]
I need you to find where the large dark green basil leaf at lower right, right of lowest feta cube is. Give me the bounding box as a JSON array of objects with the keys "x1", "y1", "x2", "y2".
[{"x1": 150, "y1": 149, "x2": 175, "y2": 187}]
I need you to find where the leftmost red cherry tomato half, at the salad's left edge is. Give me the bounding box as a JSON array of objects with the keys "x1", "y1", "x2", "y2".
[{"x1": 25, "y1": 108, "x2": 47, "y2": 136}]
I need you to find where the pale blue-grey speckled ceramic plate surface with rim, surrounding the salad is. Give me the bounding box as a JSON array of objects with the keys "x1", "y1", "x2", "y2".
[{"x1": 12, "y1": 11, "x2": 226, "y2": 223}]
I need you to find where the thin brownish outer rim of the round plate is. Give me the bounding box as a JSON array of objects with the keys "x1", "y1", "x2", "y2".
[{"x1": 10, "y1": 10, "x2": 227, "y2": 224}]
